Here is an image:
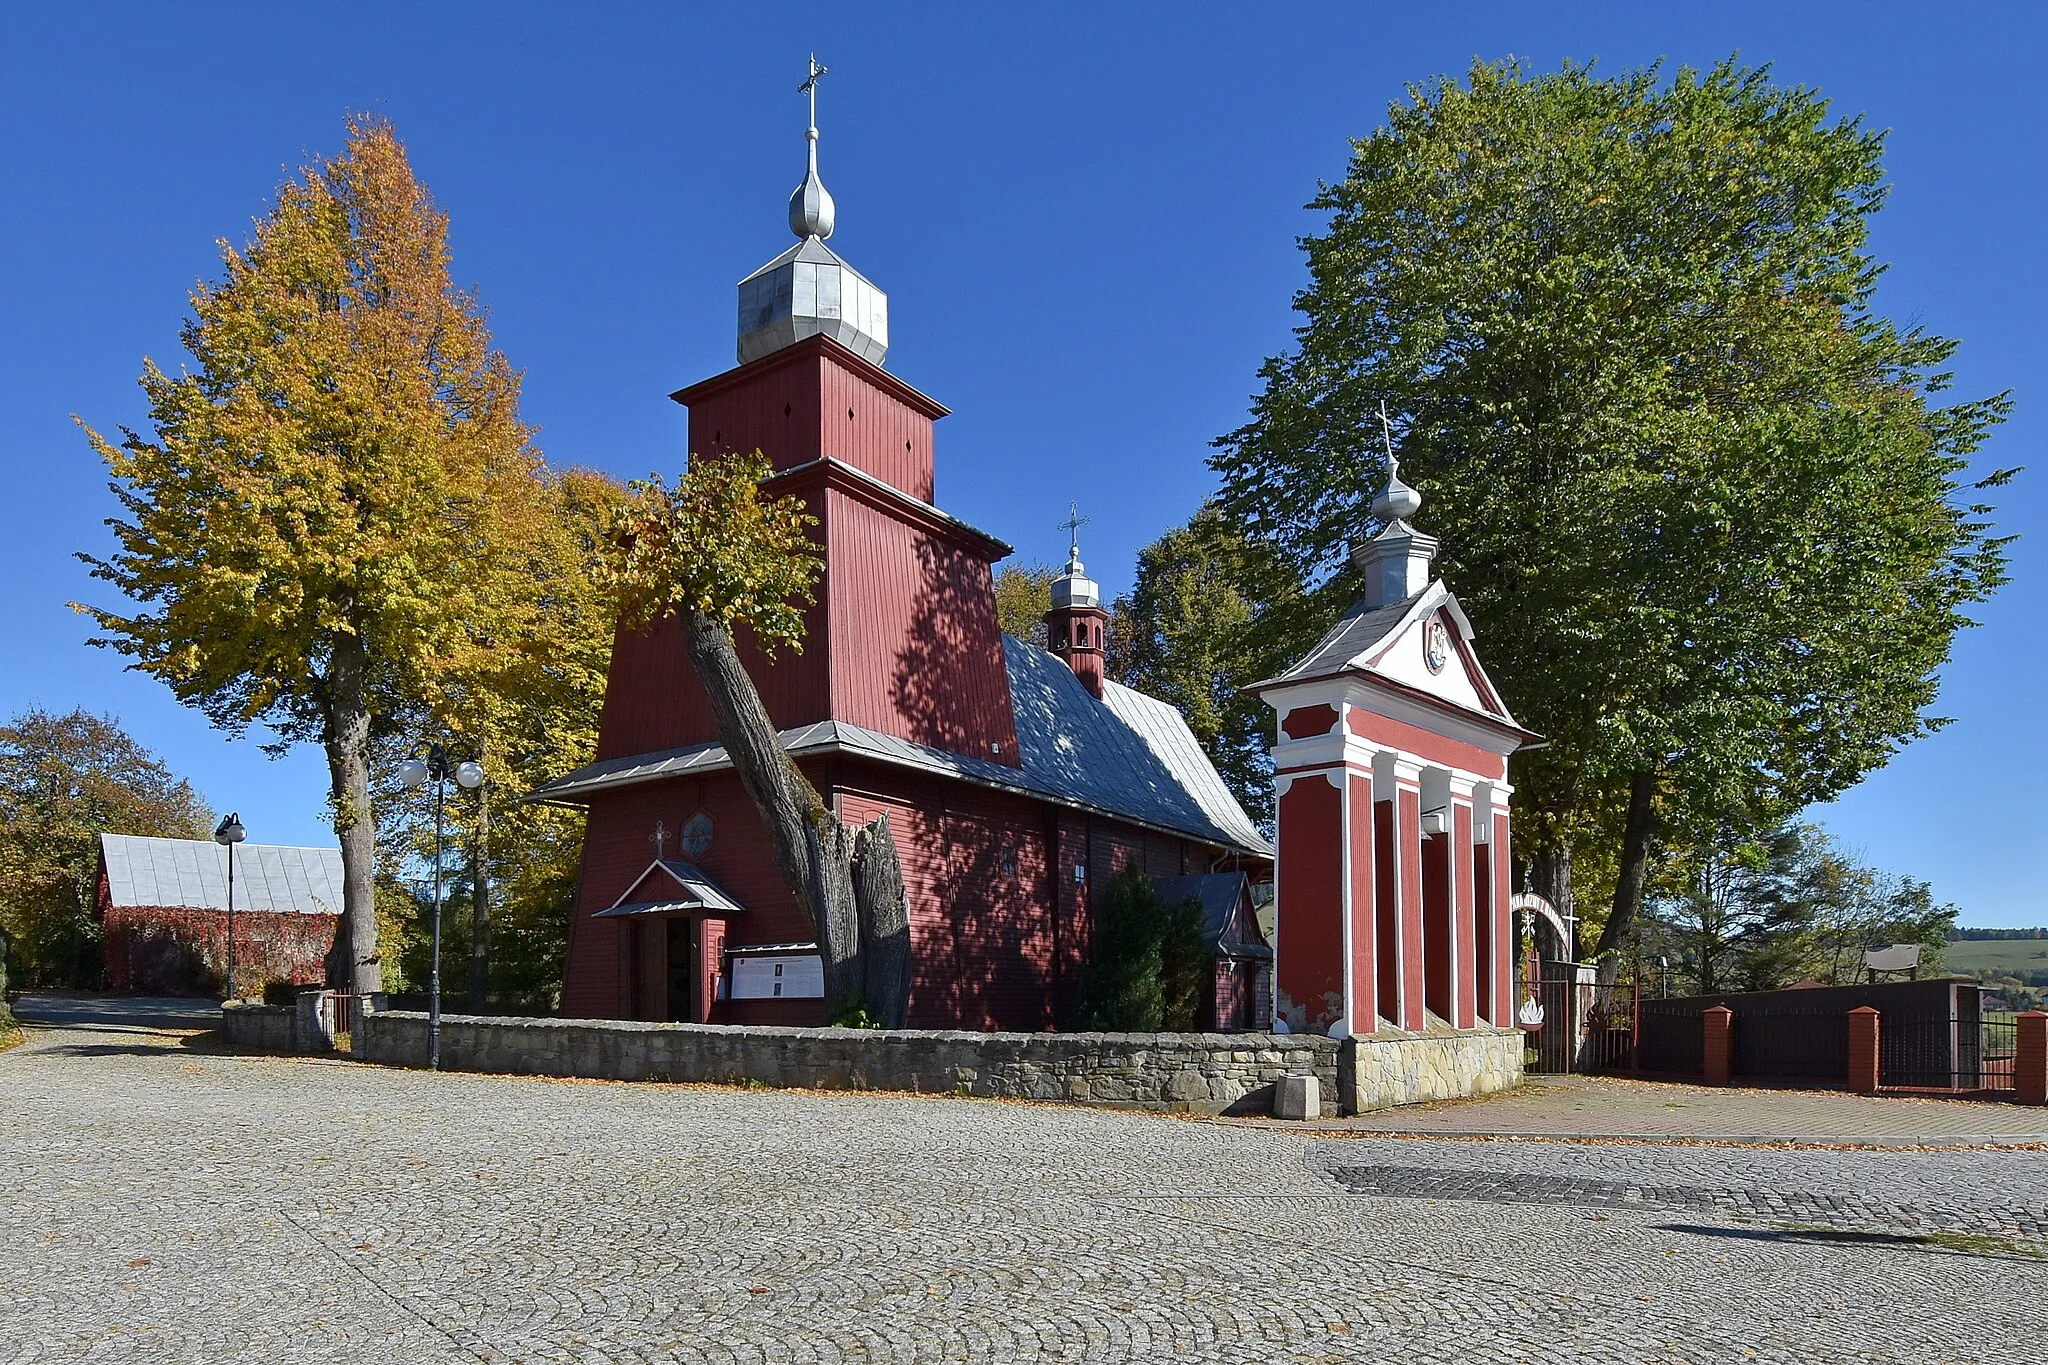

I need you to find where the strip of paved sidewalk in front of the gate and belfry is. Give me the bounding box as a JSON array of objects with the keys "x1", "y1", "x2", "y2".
[{"x1": 1249, "y1": 1076, "x2": 2048, "y2": 1146}]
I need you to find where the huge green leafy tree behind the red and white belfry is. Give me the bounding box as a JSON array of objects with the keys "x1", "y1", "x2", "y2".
[{"x1": 1214, "y1": 61, "x2": 2009, "y2": 972}]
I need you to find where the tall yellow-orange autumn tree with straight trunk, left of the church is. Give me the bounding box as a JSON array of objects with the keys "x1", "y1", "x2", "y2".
[{"x1": 82, "y1": 117, "x2": 541, "y2": 990}]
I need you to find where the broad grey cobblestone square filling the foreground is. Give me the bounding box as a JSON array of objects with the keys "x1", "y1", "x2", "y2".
[{"x1": 0, "y1": 1029, "x2": 2048, "y2": 1365}]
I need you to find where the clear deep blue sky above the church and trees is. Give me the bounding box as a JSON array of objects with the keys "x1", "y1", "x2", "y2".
[{"x1": 0, "y1": 4, "x2": 2048, "y2": 925}]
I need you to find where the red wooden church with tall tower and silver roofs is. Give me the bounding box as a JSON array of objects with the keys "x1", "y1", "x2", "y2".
[{"x1": 537, "y1": 96, "x2": 1272, "y2": 1029}]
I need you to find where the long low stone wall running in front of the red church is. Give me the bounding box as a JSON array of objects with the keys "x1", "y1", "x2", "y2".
[{"x1": 354, "y1": 1011, "x2": 1343, "y2": 1113}]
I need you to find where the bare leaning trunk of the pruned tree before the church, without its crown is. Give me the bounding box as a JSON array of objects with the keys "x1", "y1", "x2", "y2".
[{"x1": 680, "y1": 608, "x2": 909, "y2": 1027}]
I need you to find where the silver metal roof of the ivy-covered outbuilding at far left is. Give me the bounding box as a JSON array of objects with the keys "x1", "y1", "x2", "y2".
[{"x1": 100, "y1": 835, "x2": 342, "y2": 915}]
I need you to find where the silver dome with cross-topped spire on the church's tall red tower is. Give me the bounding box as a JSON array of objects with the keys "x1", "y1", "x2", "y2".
[{"x1": 739, "y1": 57, "x2": 889, "y2": 364}]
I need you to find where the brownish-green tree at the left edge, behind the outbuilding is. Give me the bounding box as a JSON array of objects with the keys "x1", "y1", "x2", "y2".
[{"x1": 0, "y1": 708, "x2": 213, "y2": 988}]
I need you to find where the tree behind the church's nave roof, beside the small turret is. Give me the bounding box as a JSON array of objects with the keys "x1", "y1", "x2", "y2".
[{"x1": 1108, "y1": 503, "x2": 1300, "y2": 821}]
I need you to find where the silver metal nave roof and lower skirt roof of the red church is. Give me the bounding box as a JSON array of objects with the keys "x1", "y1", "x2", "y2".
[{"x1": 532, "y1": 636, "x2": 1272, "y2": 857}]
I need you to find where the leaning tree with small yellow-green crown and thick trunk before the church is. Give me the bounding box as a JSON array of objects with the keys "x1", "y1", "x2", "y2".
[{"x1": 608, "y1": 452, "x2": 909, "y2": 1027}]
